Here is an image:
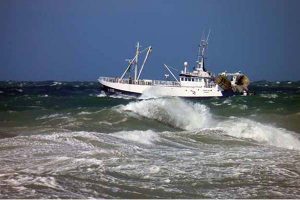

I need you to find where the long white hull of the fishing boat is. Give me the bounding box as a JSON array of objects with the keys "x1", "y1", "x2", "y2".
[{"x1": 99, "y1": 79, "x2": 223, "y2": 98}]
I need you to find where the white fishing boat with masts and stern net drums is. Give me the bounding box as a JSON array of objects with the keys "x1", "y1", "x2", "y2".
[{"x1": 98, "y1": 34, "x2": 249, "y2": 98}]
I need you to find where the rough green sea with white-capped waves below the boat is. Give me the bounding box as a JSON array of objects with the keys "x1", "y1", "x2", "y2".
[{"x1": 0, "y1": 81, "x2": 300, "y2": 199}]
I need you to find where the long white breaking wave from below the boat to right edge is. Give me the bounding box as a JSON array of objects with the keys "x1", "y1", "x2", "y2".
[{"x1": 121, "y1": 98, "x2": 300, "y2": 150}]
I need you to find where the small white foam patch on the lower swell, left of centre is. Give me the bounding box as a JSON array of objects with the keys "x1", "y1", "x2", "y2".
[{"x1": 112, "y1": 130, "x2": 159, "y2": 145}]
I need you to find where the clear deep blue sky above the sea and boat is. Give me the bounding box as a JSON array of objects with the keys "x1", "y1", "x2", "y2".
[{"x1": 0, "y1": 0, "x2": 300, "y2": 81}]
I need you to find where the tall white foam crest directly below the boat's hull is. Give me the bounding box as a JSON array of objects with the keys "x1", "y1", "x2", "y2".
[{"x1": 121, "y1": 98, "x2": 211, "y2": 130}]
